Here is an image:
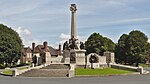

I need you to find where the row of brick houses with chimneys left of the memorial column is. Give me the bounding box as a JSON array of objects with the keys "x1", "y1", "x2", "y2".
[{"x1": 21, "y1": 42, "x2": 63, "y2": 65}]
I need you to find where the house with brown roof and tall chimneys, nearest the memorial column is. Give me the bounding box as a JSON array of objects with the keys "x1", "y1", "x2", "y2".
[{"x1": 32, "y1": 42, "x2": 63, "y2": 65}]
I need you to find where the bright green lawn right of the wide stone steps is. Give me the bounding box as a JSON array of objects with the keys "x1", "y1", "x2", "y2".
[{"x1": 75, "y1": 68, "x2": 133, "y2": 76}]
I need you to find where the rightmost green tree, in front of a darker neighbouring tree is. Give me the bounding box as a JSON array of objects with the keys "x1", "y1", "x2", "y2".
[{"x1": 128, "y1": 30, "x2": 148, "y2": 66}]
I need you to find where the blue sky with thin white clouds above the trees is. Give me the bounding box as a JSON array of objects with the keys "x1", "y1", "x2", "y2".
[{"x1": 0, "y1": 0, "x2": 150, "y2": 48}]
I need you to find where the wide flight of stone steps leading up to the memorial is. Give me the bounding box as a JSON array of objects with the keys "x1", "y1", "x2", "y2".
[{"x1": 19, "y1": 64, "x2": 69, "y2": 77}]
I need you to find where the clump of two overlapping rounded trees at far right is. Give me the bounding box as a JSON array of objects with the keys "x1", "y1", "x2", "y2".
[{"x1": 116, "y1": 30, "x2": 149, "y2": 66}]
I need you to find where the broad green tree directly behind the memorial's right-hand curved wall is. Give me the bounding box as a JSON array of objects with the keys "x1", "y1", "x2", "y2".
[{"x1": 85, "y1": 33, "x2": 115, "y2": 55}]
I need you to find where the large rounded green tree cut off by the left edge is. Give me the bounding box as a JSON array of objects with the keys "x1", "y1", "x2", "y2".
[{"x1": 0, "y1": 24, "x2": 23, "y2": 65}]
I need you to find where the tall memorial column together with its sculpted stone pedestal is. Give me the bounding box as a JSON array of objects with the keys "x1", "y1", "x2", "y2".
[{"x1": 63, "y1": 4, "x2": 86, "y2": 65}]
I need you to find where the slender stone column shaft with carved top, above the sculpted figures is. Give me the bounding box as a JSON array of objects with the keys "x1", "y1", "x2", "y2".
[{"x1": 70, "y1": 4, "x2": 77, "y2": 39}]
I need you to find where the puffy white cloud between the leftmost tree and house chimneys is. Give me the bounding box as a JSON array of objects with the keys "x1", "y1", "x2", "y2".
[{"x1": 16, "y1": 27, "x2": 42, "y2": 47}]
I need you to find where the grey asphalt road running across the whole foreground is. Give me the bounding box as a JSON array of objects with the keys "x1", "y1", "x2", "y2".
[{"x1": 0, "y1": 68, "x2": 150, "y2": 84}]
